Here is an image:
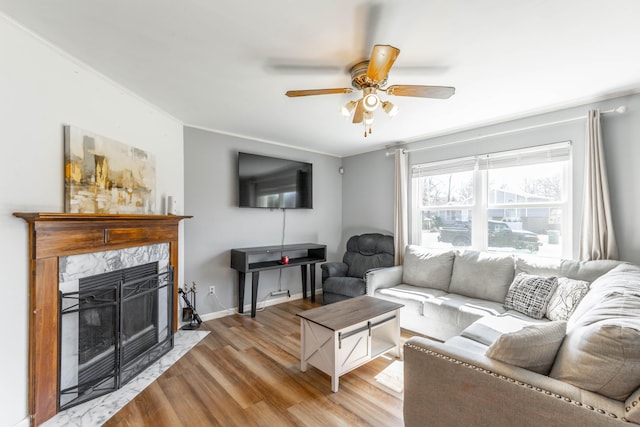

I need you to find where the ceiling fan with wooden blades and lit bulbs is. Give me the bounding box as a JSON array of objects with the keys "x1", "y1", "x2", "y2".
[{"x1": 286, "y1": 44, "x2": 455, "y2": 137}]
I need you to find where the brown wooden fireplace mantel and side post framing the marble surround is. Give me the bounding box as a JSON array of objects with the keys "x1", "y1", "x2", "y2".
[{"x1": 13, "y1": 212, "x2": 191, "y2": 426}]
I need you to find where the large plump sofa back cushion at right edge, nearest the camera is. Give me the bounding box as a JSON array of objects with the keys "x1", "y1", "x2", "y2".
[{"x1": 550, "y1": 317, "x2": 640, "y2": 401}]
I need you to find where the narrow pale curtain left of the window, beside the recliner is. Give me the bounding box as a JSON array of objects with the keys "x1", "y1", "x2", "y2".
[{"x1": 393, "y1": 148, "x2": 409, "y2": 265}]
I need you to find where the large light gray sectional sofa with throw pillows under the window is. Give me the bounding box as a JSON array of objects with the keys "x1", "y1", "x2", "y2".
[{"x1": 367, "y1": 246, "x2": 640, "y2": 426}]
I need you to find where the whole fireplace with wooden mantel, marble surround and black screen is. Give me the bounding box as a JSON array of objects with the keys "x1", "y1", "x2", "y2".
[{"x1": 14, "y1": 212, "x2": 191, "y2": 426}]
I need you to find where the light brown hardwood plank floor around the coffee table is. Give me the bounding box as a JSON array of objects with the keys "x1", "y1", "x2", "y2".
[{"x1": 104, "y1": 296, "x2": 411, "y2": 427}]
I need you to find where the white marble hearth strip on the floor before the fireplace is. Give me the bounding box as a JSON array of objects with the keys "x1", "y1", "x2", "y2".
[{"x1": 41, "y1": 330, "x2": 209, "y2": 427}]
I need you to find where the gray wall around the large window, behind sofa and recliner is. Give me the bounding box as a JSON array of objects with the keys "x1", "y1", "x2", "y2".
[{"x1": 342, "y1": 94, "x2": 640, "y2": 263}]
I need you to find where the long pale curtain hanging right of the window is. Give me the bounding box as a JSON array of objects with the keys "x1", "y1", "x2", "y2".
[{"x1": 580, "y1": 110, "x2": 618, "y2": 260}]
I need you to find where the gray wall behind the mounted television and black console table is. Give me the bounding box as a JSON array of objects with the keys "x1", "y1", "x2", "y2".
[{"x1": 184, "y1": 127, "x2": 344, "y2": 315}]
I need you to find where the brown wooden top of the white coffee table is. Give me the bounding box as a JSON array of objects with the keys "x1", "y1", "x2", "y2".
[{"x1": 297, "y1": 295, "x2": 403, "y2": 331}]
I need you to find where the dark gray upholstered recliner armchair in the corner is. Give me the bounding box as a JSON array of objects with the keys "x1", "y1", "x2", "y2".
[{"x1": 320, "y1": 233, "x2": 394, "y2": 304}]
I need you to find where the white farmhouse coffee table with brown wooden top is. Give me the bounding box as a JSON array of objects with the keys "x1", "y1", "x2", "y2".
[{"x1": 297, "y1": 295, "x2": 403, "y2": 392}]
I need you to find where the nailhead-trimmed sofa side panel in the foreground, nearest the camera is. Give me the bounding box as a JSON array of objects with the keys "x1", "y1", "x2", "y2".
[{"x1": 403, "y1": 337, "x2": 624, "y2": 427}]
